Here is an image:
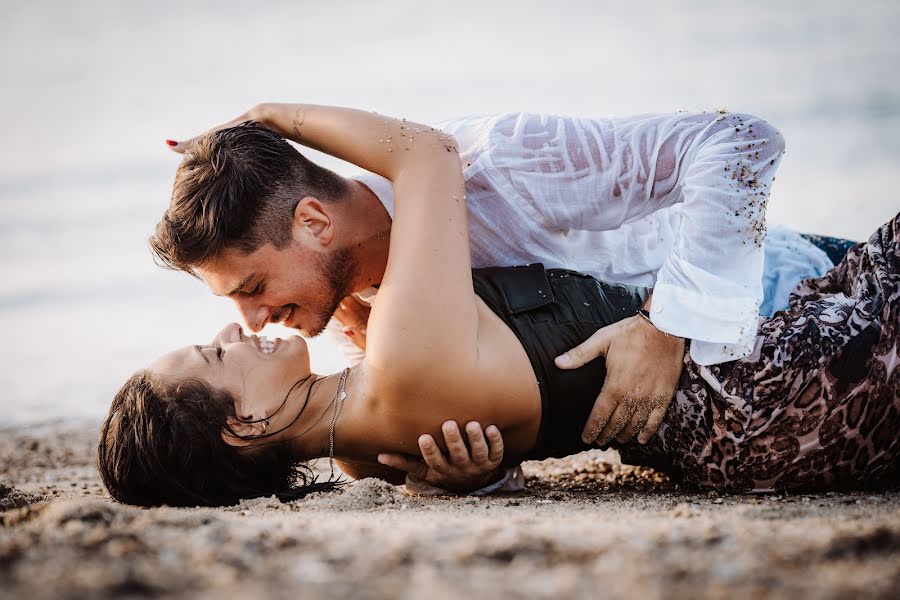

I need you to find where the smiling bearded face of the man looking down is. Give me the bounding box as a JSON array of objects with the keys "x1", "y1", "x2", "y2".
[{"x1": 197, "y1": 241, "x2": 356, "y2": 336}]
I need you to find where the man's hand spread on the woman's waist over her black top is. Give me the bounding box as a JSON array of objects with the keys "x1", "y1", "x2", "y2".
[{"x1": 556, "y1": 304, "x2": 684, "y2": 447}]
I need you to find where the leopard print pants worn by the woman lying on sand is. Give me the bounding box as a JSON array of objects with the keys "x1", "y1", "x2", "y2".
[{"x1": 620, "y1": 215, "x2": 900, "y2": 491}]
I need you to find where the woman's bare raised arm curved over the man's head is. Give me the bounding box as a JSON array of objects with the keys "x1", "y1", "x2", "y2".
[{"x1": 173, "y1": 104, "x2": 477, "y2": 387}]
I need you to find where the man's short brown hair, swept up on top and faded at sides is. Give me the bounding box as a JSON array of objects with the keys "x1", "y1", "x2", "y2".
[{"x1": 150, "y1": 121, "x2": 347, "y2": 274}]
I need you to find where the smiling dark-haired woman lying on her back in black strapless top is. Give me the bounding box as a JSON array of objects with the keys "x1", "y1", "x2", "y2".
[{"x1": 100, "y1": 107, "x2": 900, "y2": 505}]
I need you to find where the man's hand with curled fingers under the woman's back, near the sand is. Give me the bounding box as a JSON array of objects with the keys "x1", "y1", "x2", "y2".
[{"x1": 378, "y1": 421, "x2": 503, "y2": 491}]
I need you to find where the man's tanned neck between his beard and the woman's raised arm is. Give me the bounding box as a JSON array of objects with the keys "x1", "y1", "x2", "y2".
[{"x1": 344, "y1": 179, "x2": 391, "y2": 292}]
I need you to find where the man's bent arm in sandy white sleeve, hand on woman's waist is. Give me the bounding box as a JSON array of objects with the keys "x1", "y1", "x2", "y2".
[{"x1": 490, "y1": 113, "x2": 784, "y2": 442}]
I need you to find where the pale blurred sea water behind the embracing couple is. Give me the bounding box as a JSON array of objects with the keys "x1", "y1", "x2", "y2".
[{"x1": 0, "y1": 0, "x2": 900, "y2": 425}]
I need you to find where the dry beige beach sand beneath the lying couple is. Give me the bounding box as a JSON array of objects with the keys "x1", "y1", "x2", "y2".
[{"x1": 0, "y1": 425, "x2": 900, "y2": 600}]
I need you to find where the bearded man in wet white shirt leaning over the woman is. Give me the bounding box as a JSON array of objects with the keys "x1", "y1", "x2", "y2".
[{"x1": 151, "y1": 104, "x2": 829, "y2": 494}]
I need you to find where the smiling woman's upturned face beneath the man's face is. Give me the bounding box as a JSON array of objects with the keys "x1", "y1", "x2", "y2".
[{"x1": 149, "y1": 323, "x2": 310, "y2": 427}]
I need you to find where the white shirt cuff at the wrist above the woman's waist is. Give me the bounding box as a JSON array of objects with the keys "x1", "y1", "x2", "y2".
[{"x1": 650, "y1": 283, "x2": 759, "y2": 365}]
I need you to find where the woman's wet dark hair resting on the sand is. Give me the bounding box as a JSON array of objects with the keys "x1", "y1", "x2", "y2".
[{"x1": 98, "y1": 371, "x2": 336, "y2": 506}]
